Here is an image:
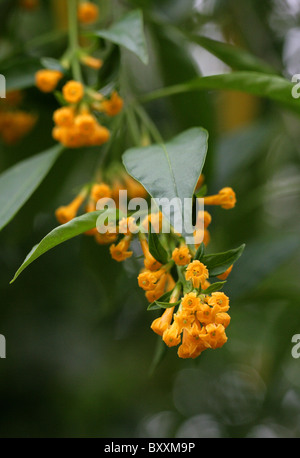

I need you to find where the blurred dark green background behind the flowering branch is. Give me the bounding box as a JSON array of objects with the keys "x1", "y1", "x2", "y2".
[{"x1": 0, "y1": 0, "x2": 300, "y2": 438}]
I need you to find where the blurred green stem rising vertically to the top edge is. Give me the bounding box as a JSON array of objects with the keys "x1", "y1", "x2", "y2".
[{"x1": 68, "y1": 0, "x2": 83, "y2": 82}]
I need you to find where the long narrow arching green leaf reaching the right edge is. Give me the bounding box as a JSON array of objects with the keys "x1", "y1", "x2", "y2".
[{"x1": 142, "y1": 71, "x2": 300, "y2": 114}]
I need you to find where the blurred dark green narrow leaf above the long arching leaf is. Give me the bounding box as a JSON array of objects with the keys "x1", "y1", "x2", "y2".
[{"x1": 187, "y1": 34, "x2": 277, "y2": 74}]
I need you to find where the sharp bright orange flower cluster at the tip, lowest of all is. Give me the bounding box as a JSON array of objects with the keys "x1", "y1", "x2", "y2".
[{"x1": 151, "y1": 290, "x2": 230, "y2": 359}]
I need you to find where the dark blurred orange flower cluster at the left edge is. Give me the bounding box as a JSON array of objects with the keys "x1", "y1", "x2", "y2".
[{"x1": 0, "y1": 91, "x2": 37, "y2": 145}]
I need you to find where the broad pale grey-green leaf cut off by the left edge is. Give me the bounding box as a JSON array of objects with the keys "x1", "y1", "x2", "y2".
[{"x1": 0, "y1": 145, "x2": 62, "y2": 230}]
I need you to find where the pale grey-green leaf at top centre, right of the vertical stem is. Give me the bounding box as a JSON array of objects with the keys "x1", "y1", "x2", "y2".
[{"x1": 93, "y1": 10, "x2": 149, "y2": 65}]
